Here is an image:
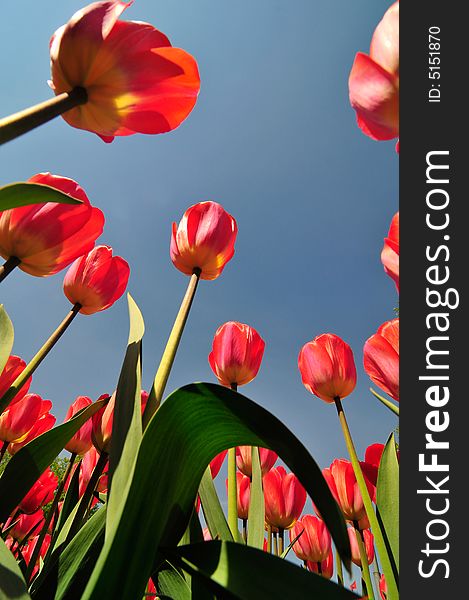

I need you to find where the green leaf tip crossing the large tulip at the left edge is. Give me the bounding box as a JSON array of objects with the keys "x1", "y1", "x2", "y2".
[{"x1": 0, "y1": 181, "x2": 82, "y2": 211}]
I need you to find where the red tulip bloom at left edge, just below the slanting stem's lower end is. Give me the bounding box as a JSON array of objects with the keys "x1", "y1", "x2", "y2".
[{"x1": 0, "y1": 394, "x2": 43, "y2": 442}]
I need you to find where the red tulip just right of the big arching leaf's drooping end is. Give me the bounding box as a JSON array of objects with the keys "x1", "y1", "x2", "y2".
[{"x1": 322, "y1": 458, "x2": 373, "y2": 521}]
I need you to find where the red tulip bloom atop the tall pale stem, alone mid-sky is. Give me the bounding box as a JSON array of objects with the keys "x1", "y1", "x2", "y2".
[{"x1": 170, "y1": 202, "x2": 238, "y2": 279}]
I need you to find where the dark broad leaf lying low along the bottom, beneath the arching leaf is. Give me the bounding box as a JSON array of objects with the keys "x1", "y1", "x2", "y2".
[{"x1": 167, "y1": 541, "x2": 358, "y2": 600}]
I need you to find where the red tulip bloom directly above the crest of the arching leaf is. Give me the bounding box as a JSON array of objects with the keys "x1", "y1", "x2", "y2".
[{"x1": 208, "y1": 321, "x2": 265, "y2": 386}]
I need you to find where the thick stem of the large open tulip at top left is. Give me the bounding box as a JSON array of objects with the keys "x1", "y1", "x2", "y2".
[{"x1": 0, "y1": 87, "x2": 88, "y2": 145}]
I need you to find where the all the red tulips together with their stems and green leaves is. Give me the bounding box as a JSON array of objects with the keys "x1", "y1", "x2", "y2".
[{"x1": 0, "y1": 0, "x2": 399, "y2": 600}]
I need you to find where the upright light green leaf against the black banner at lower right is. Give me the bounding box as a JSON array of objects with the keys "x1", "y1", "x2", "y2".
[{"x1": 376, "y1": 433, "x2": 399, "y2": 575}]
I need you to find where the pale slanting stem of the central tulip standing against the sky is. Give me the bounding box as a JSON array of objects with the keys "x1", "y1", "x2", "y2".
[{"x1": 143, "y1": 268, "x2": 201, "y2": 429}]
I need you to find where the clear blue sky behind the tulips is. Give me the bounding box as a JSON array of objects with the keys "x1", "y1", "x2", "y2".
[{"x1": 0, "y1": 0, "x2": 398, "y2": 478}]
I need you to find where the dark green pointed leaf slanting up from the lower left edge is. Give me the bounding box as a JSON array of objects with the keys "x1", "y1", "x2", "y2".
[{"x1": 0, "y1": 400, "x2": 107, "y2": 523}]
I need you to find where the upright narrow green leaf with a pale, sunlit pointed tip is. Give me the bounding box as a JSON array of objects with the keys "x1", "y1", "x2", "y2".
[{"x1": 106, "y1": 294, "x2": 145, "y2": 537}]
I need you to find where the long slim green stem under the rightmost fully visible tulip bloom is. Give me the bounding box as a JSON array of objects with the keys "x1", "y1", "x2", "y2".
[{"x1": 334, "y1": 396, "x2": 399, "y2": 600}]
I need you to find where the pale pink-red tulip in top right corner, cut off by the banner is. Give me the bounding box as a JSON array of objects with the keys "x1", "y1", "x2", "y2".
[{"x1": 349, "y1": 2, "x2": 399, "y2": 140}]
